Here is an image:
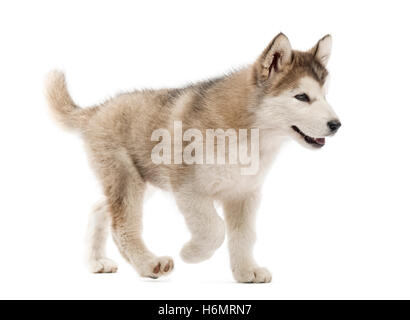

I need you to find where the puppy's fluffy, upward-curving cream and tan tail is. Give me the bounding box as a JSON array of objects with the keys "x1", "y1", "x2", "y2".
[{"x1": 46, "y1": 71, "x2": 98, "y2": 130}]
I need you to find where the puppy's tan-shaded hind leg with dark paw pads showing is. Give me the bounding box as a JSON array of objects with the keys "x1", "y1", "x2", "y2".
[{"x1": 94, "y1": 154, "x2": 174, "y2": 278}]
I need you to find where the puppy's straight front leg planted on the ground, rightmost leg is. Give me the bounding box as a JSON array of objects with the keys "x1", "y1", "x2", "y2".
[{"x1": 224, "y1": 192, "x2": 272, "y2": 283}]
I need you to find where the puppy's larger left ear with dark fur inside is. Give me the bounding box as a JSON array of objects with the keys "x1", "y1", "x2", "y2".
[{"x1": 254, "y1": 33, "x2": 292, "y2": 82}]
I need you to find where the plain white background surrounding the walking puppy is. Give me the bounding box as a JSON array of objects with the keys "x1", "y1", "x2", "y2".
[{"x1": 0, "y1": 0, "x2": 410, "y2": 299}]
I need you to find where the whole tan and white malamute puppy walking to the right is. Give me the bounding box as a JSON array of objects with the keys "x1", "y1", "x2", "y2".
[{"x1": 46, "y1": 34, "x2": 341, "y2": 283}]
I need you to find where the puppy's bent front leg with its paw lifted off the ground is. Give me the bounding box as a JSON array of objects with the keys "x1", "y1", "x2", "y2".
[{"x1": 175, "y1": 190, "x2": 225, "y2": 263}]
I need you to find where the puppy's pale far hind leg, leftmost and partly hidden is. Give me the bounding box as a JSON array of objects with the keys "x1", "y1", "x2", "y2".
[{"x1": 87, "y1": 201, "x2": 118, "y2": 273}]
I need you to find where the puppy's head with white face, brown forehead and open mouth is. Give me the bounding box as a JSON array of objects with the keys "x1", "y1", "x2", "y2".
[{"x1": 252, "y1": 33, "x2": 341, "y2": 148}]
